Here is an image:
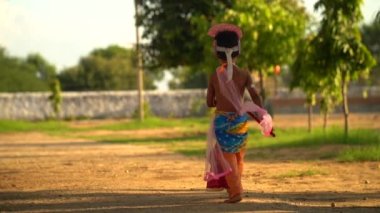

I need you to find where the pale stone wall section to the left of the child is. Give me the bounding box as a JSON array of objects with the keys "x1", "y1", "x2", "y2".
[{"x1": 0, "y1": 90, "x2": 206, "y2": 120}]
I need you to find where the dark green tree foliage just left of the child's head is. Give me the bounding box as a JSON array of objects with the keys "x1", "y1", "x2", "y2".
[{"x1": 139, "y1": 0, "x2": 234, "y2": 68}]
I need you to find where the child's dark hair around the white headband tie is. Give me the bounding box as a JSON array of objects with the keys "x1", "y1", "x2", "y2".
[{"x1": 215, "y1": 31, "x2": 240, "y2": 61}]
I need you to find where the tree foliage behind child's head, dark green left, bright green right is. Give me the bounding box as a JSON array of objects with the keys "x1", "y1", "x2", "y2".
[{"x1": 140, "y1": 0, "x2": 308, "y2": 90}]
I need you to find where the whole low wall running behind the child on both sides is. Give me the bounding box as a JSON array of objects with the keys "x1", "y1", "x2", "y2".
[{"x1": 0, "y1": 88, "x2": 380, "y2": 120}]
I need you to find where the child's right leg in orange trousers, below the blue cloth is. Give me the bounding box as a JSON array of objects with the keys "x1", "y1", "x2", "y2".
[{"x1": 223, "y1": 152, "x2": 242, "y2": 198}]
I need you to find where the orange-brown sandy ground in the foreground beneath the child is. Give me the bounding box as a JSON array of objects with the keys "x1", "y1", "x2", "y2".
[{"x1": 0, "y1": 115, "x2": 380, "y2": 212}]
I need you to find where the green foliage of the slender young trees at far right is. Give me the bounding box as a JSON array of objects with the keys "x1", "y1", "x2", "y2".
[{"x1": 291, "y1": 0, "x2": 378, "y2": 131}]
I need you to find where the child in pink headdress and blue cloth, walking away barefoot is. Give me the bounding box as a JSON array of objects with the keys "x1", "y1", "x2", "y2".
[{"x1": 205, "y1": 24, "x2": 272, "y2": 203}]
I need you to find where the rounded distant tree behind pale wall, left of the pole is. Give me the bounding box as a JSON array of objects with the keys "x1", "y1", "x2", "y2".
[{"x1": 58, "y1": 45, "x2": 155, "y2": 91}]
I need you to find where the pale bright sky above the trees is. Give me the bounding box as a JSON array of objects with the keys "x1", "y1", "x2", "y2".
[{"x1": 0, "y1": 0, "x2": 380, "y2": 89}]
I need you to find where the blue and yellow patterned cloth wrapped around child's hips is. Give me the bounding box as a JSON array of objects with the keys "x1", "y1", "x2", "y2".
[{"x1": 214, "y1": 111, "x2": 248, "y2": 153}]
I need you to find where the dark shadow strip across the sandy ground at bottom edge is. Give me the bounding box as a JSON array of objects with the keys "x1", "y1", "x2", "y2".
[{"x1": 0, "y1": 189, "x2": 380, "y2": 212}]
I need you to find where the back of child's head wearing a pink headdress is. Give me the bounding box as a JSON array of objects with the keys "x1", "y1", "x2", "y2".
[{"x1": 208, "y1": 24, "x2": 242, "y2": 61}]
